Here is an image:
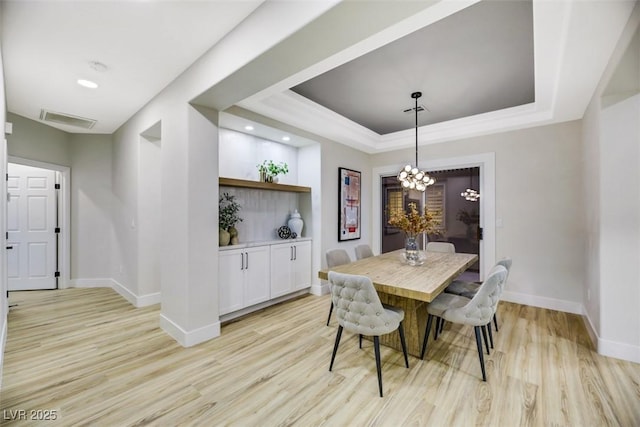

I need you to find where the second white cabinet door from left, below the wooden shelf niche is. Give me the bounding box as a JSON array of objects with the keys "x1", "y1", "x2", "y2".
[{"x1": 244, "y1": 246, "x2": 270, "y2": 307}]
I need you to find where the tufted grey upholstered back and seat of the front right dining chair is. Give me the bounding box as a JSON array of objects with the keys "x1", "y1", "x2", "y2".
[{"x1": 443, "y1": 265, "x2": 507, "y2": 326}]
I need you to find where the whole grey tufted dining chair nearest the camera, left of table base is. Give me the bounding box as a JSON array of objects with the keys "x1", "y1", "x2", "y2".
[{"x1": 329, "y1": 271, "x2": 409, "y2": 397}]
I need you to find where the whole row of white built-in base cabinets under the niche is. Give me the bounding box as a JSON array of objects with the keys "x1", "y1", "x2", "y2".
[{"x1": 218, "y1": 240, "x2": 311, "y2": 316}]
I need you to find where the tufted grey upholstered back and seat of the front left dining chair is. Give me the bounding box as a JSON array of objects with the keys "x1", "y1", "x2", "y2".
[{"x1": 329, "y1": 271, "x2": 402, "y2": 336}]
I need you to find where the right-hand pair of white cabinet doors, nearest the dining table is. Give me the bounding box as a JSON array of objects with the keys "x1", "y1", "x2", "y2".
[{"x1": 271, "y1": 241, "x2": 311, "y2": 298}]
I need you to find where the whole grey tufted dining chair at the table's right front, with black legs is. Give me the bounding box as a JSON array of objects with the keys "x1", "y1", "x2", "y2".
[{"x1": 420, "y1": 265, "x2": 507, "y2": 381}]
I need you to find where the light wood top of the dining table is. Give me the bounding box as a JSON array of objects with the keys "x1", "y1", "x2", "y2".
[{"x1": 318, "y1": 249, "x2": 478, "y2": 302}]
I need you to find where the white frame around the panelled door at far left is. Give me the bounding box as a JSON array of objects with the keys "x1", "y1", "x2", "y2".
[{"x1": 7, "y1": 156, "x2": 71, "y2": 289}]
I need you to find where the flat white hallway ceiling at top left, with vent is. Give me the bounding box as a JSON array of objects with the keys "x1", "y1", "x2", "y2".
[{"x1": 1, "y1": 0, "x2": 264, "y2": 133}]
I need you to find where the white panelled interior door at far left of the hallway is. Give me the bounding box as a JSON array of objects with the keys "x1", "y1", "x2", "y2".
[{"x1": 7, "y1": 163, "x2": 57, "y2": 291}]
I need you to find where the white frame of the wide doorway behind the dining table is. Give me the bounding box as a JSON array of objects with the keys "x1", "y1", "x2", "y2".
[{"x1": 371, "y1": 152, "x2": 496, "y2": 280}]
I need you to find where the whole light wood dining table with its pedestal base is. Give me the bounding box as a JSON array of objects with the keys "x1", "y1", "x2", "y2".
[{"x1": 318, "y1": 249, "x2": 478, "y2": 357}]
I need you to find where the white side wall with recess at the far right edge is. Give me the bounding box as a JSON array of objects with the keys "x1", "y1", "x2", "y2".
[{"x1": 582, "y1": 4, "x2": 640, "y2": 363}]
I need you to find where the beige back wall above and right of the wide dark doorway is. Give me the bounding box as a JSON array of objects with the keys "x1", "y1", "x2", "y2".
[{"x1": 372, "y1": 121, "x2": 585, "y2": 313}]
